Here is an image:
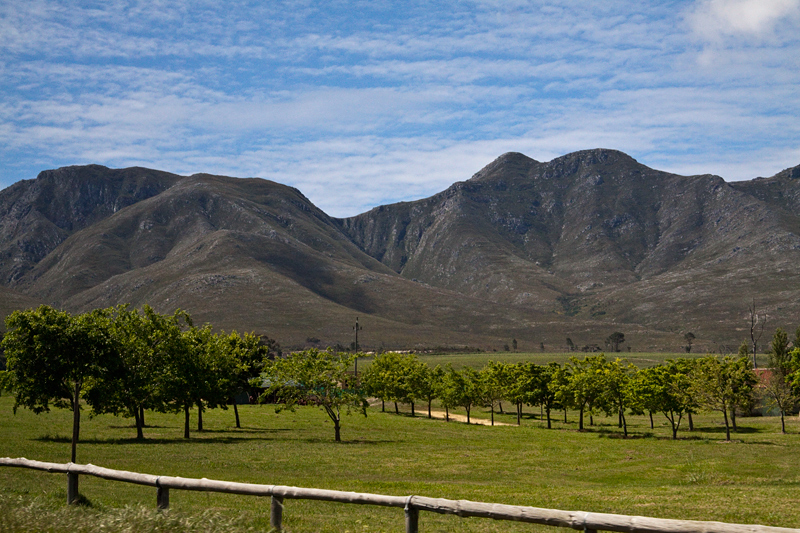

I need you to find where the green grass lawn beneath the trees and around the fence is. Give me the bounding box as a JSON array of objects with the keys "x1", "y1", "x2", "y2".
[{"x1": 0, "y1": 395, "x2": 800, "y2": 532}]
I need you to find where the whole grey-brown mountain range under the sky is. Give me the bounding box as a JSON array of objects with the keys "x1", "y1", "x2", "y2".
[{"x1": 0, "y1": 149, "x2": 800, "y2": 351}]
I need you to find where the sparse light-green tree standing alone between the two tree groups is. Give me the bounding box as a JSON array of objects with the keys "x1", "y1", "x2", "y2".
[{"x1": 262, "y1": 348, "x2": 368, "y2": 442}]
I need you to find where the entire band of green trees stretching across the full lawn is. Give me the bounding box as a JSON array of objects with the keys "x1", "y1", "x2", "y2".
[{"x1": 0, "y1": 306, "x2": 800, "y2": 448}]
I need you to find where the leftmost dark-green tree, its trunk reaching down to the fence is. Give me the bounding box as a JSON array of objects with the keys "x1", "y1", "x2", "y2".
[{"x1": 2, "y1": 305, "x2": 116, "y2": 463}]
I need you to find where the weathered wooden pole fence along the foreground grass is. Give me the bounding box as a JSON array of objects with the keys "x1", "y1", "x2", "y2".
[{"x1": 0, "y1": 457, "x2": 800, "y2": 533}]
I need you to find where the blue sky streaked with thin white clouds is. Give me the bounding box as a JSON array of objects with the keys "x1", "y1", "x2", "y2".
[{"x1": 0, "y1": 0, "x2": 800, "y2": 217}]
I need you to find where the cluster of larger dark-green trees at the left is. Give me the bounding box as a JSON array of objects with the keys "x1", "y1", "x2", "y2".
[{"x1": 0, "y1": 306, "x2": 279, "y2": 462}]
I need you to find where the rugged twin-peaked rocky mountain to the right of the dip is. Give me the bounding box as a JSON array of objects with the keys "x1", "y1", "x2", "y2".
[{"x1": 341, "y1": 150, "x2": 800, "y2": 342}]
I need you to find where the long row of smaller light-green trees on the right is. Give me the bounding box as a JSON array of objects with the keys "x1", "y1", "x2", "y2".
[{"x1": 360, "y1": 329, "x2": 800, "y2": 440}]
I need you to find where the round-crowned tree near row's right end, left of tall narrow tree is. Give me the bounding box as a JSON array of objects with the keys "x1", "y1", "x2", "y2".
[{"x1": 691, "y1": 355, "x2": 757, "y2": 440}]
